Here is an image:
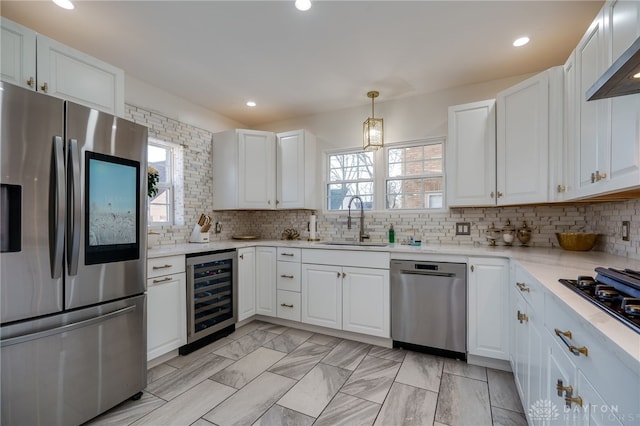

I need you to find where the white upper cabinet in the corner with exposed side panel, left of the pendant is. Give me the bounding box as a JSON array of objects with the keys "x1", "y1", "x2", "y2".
[{"x1": 213, "y1": 129, "x2": 275, "y2": 210}]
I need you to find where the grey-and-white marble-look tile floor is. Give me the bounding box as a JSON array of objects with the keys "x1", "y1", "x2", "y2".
[{"x1": 87, "y1": 321, "x2": 526, "y2": 426}]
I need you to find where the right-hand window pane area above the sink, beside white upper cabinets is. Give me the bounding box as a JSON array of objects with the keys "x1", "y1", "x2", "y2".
[{"x1": 385, "y1": 139, "x2": 444, "y2": 210}]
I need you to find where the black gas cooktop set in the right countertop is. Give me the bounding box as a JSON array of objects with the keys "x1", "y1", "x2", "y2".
[{"x1": 558, "y1": 276, "x2": 640, "y2": 334}]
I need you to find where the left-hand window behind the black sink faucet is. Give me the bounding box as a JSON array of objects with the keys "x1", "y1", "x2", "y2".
[{"x1": 326, "y1": 151, "x2": 374, "y2": 211}]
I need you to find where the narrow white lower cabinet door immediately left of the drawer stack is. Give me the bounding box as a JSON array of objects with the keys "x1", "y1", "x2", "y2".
[{"x1": 256, "y1": 247, "x2": 277, "y2": 317}]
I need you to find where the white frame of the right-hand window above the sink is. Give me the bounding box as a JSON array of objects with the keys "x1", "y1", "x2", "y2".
[{"x1": 381, "y1": 136, "x2": 447, "y2": 213}]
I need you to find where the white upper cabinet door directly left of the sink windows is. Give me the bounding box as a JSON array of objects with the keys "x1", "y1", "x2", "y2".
[{"x1": 276, "y1": 130, "x2": 306, "y2": 209}]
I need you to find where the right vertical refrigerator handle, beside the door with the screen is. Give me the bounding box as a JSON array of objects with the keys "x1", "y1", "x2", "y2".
[{"x1": 67, "y1": 139, "x2": 81, "y2": 276}]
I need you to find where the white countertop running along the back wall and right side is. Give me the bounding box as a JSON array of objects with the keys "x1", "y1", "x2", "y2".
[{"x1": 148, "y1": 240, "x2": 640, "y2": 369}]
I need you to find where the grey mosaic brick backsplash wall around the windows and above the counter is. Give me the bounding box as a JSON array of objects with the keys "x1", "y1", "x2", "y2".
[{"x1": 126, "y1": 105, "x2": 640, "y2": 259}]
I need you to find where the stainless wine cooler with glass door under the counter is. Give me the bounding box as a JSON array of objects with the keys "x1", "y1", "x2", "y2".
[{"x1": 179, "y1": 249, "x2": 238, "y2": 355}]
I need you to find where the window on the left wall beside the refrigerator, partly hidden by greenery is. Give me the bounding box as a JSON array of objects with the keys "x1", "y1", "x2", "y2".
[{"x1": 147, "y1": 140, "x2": 175, "y2": 225}]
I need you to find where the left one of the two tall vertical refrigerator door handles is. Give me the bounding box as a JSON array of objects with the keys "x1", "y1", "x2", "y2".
[{"x1": 49, "y1": 136, "x2": 66, "y2": 279}]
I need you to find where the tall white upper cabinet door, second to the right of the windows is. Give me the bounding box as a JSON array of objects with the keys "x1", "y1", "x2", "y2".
[{"x1": 496, "y1": 72, "x2": 549, "y2": 205}]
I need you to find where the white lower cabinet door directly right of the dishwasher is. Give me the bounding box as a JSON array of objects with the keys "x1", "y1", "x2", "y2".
[{"x1": 467, "y1": 258, "x2": 509, "y2": 360}]
